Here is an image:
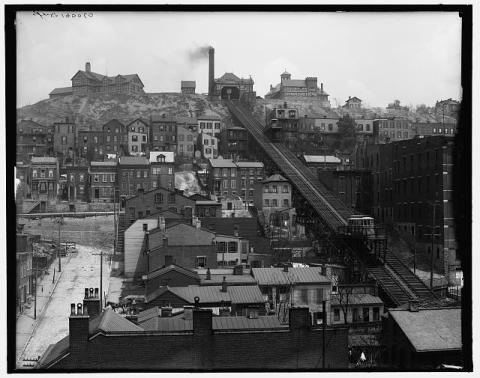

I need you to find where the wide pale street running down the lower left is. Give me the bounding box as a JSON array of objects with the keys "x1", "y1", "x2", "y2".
[{"x1": 16, "y1": 245, "x2": 111, "y2": 368}]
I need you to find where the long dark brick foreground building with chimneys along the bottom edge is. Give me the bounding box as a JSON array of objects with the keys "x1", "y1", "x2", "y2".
[{"x1": 38, "y1": 299, "x2": 348, "y2": 371}]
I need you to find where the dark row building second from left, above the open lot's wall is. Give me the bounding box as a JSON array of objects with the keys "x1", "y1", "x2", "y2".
[{"x1": 60, "y1": 162, "x2": 89, "y2": 202}]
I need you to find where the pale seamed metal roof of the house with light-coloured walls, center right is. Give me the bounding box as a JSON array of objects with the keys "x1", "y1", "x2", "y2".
[{"x1": 252, "y1": 267, "x2": 330, "y2": 286}]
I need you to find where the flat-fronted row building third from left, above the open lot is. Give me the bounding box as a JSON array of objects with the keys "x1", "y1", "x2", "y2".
[{"x1": 88, "y1": 161, "x2": 118, "y2": 202}]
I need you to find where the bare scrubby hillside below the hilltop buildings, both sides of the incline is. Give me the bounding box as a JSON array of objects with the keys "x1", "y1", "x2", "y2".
[{"x1": 17, "y1": 93, "x2": 456, "y2": 128}]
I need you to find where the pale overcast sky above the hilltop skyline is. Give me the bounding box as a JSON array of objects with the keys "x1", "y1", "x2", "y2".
[{"x1": 17, "y1": 12, "x2": 461, "y2": 107}]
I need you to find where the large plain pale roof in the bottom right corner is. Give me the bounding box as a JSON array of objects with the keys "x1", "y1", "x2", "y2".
[{"x1": 389, "y1": 308, "x2": 462, "y2": 352}]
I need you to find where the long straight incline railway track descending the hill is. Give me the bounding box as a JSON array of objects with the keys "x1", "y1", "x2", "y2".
[{"x1": 226, "y1": 101, "x2": 436, "y2": 305}]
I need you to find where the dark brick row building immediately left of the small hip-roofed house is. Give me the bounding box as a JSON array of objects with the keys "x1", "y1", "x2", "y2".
[{"x1": 236, "y1": 161, "x2": 265, "y2": 205}]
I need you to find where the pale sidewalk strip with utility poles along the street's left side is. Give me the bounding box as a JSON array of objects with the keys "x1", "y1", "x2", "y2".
[{"x1": 16, "y1": 255, "x2": 71, "y2": 366}]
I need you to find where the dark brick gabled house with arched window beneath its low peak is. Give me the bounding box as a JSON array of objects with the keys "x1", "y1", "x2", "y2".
[{"x1": 125, "y1": 188, "x2": 196, "y2": 226}]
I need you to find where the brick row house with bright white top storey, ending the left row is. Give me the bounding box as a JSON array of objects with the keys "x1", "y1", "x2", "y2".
[{"x1": 149, "y1": 151, "x2": 175, "y2": 190}]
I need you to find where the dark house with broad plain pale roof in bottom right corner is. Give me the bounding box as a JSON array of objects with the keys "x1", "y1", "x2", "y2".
[{"x1": 383, "y1": 303, "x2": 463, "y2": 370}]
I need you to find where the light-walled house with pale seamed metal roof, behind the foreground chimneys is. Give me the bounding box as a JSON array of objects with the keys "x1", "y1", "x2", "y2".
[{"x1": 251, "y1": 265, "x2": 331, "y2": 324}]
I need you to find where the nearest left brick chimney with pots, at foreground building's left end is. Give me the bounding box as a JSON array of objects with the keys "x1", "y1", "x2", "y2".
[{"x1": 68, "y1": 303, "x2": 90, "y2": 358}]
